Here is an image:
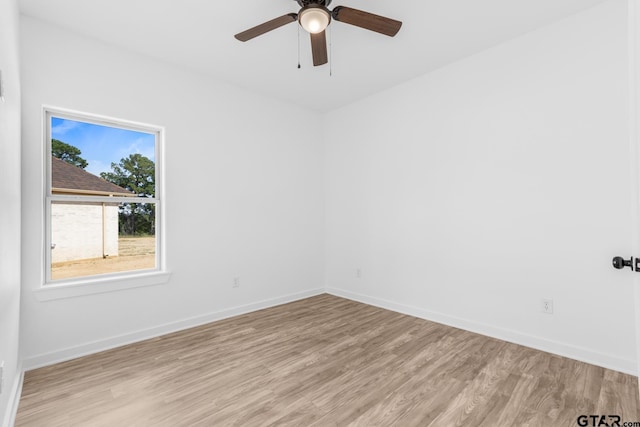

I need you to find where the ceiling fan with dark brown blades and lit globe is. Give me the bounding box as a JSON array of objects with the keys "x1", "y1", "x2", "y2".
[{"x1": 235, "y1": 0, "x2": 402, "y2": 66}]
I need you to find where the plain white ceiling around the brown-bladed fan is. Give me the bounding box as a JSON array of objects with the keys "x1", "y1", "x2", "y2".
[{"x1": 19, "y1": 0, "x2": 605, "y2": 112}]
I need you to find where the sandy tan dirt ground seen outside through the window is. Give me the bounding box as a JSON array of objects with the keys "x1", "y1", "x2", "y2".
[{"x1": 51, "y1": 236, "x2": 156, "y2": 280}]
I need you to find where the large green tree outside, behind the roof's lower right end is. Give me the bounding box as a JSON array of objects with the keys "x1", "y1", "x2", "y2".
[{"x1": 100, "y1": 154, "x2": 156, "y2": 235}]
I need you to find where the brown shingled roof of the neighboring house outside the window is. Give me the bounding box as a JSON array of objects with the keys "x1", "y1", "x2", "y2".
[{"x1": 51, "y1": 156, "x2": 136, "y2": 197}]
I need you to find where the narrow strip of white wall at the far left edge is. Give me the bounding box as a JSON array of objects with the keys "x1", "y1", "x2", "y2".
[{"x1": 0, "y1": 0, "x2": 21, "y2": 426}]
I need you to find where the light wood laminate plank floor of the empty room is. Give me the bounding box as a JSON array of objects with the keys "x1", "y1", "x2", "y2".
[{"x1": 16, "y1": 294, "x2": 640, "y2": 427}]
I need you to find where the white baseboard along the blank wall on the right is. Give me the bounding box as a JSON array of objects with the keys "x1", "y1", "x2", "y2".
[{"x1": 326, "y1": 288, "x2": 638, "y2": 376}]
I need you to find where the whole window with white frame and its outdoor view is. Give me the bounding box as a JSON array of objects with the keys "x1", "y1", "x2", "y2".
[{"x1": 44, "y1": 108, "x2": 163, "y2": 286}]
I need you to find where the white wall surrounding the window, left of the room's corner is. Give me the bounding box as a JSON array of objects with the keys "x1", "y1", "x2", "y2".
[{"x1": 21, "y1": 17, "x2": 324, "y2": 368}]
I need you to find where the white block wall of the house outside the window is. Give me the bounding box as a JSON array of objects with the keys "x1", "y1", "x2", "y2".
[{"x1": 51, "y1": 202, "x2": 118, "y2": 263}]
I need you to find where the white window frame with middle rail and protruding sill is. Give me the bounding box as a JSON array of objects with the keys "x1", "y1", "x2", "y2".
[{"x1": 37, "y1": 106, "x2": 170, "y2": 300}]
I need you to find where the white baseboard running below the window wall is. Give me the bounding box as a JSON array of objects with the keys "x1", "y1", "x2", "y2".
[{"x1": 22, "y1": 288, "x2": 325, "y2": 371}]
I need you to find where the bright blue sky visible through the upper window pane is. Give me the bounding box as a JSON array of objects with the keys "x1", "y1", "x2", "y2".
[{"x1": 51, "y1": 117, "x2": 156, "y2": 176}]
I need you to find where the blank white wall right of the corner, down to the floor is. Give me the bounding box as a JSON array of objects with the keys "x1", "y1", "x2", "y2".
[{"x1": 326, "y1": 1, "x2": 636, "y2": 373}]
